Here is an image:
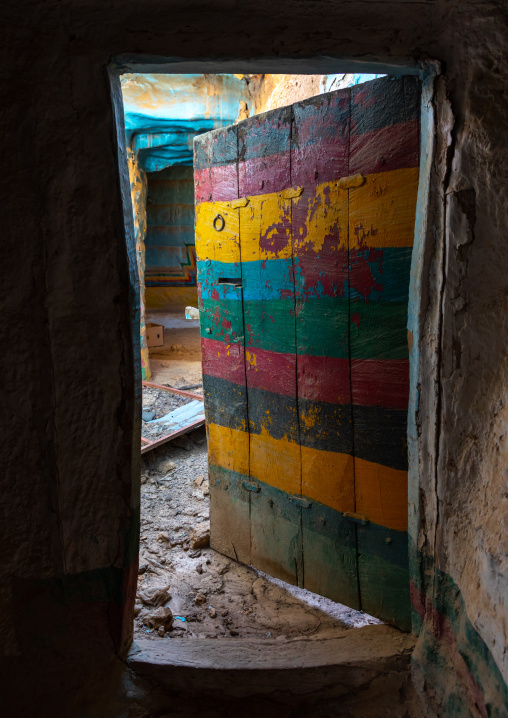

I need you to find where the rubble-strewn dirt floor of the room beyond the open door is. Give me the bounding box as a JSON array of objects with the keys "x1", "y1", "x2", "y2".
[{"x1": 134, "y1": 312, "x2": 380, "y2": 640}]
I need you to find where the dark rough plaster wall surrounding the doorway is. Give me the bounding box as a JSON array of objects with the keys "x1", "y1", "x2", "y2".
[{"x1": 0, "y1": 0, "x2": 508, "y2": 716}]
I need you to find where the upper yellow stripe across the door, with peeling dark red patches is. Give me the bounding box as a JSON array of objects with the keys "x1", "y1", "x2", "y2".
[{"x1": 196, "y1": 167, "x2": 418, "y2": 263}]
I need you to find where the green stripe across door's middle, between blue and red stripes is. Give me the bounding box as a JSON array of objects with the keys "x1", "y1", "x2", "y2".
[{"x1": 201, "y1": 297, "x2": 408, "y2": 359}]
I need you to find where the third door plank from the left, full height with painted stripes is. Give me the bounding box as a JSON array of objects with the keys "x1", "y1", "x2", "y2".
[{"x1": 291, "y1": 90, "x2": 359, "y2": 608}]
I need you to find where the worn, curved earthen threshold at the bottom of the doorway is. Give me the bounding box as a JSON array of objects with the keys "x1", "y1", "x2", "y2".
[{"x1": 127, "y1": 625, "x2": 415, "y2": 697}]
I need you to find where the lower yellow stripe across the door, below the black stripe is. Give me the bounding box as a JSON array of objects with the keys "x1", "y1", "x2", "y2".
[{"x1": 208, "y1": 424, "x2": 408, "y2": 531}]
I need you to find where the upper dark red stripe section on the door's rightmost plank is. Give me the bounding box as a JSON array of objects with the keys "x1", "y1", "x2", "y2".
[{"x1": 349, "y1": 117, "x2": 420, "y2": 175}]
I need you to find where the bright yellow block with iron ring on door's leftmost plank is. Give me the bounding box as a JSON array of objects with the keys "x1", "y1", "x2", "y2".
[{"x1": 196, "y1": 202, "x2": 240, "y2": 264}]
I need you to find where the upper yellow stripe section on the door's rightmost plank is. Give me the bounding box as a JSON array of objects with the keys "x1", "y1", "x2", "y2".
[{"x1": 349, "y1": 167, "x2": 418, "y2": 249}]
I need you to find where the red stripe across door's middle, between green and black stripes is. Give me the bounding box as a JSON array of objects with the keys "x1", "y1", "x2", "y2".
[{"x1": 201, "y1": 339, "x2": 409, "y2": 410}]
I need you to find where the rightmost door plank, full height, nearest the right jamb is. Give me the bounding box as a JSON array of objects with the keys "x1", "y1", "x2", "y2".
[{"x1": 349, "y1": 78, "x2": 419, "y2": 630}]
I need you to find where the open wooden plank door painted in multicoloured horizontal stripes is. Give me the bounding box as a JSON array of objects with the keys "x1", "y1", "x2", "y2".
[{"x1": 194, "y1": 77, "x2": 419, "y2": 629}]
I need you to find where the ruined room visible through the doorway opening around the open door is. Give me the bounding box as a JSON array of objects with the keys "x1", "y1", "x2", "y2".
[{"x1": 116, "y1": 74, "x2": 420, "y2": 640}]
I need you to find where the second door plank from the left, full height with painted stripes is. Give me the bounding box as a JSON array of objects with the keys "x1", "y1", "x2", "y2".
[{"x1": 238, "y1": 108, "x2": 302, "y2": 584}]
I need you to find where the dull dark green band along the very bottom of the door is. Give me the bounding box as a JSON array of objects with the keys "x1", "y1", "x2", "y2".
[{"x1": 210, "y1": 466, "x2": 411, "y2": 631}]
